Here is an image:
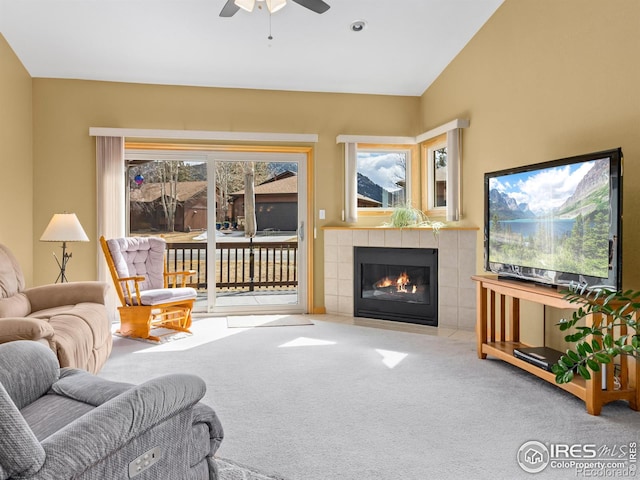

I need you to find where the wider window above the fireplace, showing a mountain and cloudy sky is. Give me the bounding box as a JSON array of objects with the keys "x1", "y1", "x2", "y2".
[{"x1": 356, "y1": 144, "x2": 411, "y2": 210}]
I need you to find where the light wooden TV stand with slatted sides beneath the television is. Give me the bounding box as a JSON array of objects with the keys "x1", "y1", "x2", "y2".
[{"x1": 471, "y1": 275, "x2": 640, "y2": 415}]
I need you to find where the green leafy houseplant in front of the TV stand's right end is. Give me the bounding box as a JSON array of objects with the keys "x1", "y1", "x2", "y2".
[{"x1": 552, "y1": 287, "x2": 640, "y2": 383}]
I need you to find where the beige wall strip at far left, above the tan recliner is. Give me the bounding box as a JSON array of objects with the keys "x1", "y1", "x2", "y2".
[{"x1": 0, "y1": 34, "x2": 33, "y2": 284}]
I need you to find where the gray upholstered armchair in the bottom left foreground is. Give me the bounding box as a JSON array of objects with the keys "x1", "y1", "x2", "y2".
[{"x1": 0, "y1": 340, "x2": 223, "y2": 480}]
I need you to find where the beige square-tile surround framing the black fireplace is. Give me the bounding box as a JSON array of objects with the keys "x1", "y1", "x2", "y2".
[{"x1": 323, "y1": 227, "x2": 477, "y2": 330}]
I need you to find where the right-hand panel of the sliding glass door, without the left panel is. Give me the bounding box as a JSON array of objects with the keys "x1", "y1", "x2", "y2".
[{"x1": 207, "y1": 153, "x2": 306, "y2": 313}]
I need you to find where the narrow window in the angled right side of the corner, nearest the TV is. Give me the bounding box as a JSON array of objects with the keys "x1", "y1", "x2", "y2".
[{"x1": 423, "y1": 135, "x2": 448, "y2": 211}]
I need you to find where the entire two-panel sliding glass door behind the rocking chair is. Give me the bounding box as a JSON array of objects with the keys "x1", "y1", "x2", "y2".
[{"x1": 126, "y1": 150, "x2": 307, "y2": 314}]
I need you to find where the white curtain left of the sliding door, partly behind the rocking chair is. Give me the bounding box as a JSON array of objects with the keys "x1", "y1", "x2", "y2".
[{"x1": 96, "y1": 137, "x2": 126, "y2": 321}]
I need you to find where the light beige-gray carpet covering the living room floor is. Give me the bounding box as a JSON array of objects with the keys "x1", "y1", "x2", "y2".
[{"x1": 98, "y1": 315, "x2": 640, "y2": 480}]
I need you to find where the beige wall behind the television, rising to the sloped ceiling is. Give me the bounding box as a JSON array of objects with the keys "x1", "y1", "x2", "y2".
[{"x1": 421, "y1": 0, "x2": 640, "y2": 348}]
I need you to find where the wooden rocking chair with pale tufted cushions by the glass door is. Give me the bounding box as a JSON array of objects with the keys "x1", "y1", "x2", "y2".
[{"x1": 100, "y1": 237, "x2": 197, "y2": 341}]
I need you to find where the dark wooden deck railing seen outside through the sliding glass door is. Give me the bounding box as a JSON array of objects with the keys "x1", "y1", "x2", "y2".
[{"x1": 167, "y1": 241, "x2": 298, "y2": 292}]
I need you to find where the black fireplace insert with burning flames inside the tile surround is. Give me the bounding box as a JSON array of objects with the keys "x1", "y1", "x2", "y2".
[{"x1": 353, "y1": 247, "x2": 438, "y2": 326}]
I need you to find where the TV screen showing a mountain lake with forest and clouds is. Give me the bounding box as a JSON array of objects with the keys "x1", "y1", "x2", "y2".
[{"x1": 489, "y1": 159, "x2": 611, "y2": 278}]
